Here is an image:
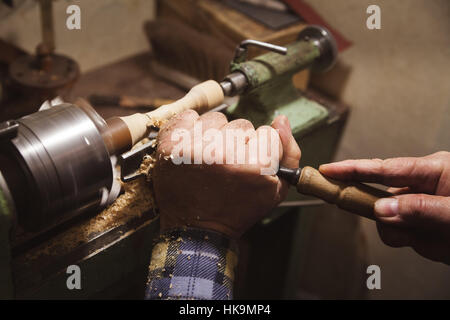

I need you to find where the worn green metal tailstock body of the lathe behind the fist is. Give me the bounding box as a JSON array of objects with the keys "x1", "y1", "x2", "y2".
[{"x1": 227, "y1": 41, "x2": 328, "y2": 138}]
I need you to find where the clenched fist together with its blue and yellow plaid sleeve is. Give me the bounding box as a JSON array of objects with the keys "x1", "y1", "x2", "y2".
[{"x1": 145, "y1": 110, "x2": 300, "y2": 300}]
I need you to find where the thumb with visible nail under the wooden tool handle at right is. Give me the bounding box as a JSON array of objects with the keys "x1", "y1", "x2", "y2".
[{"x1": 374, "y1": 194, "x2": 450, "y2": 234}]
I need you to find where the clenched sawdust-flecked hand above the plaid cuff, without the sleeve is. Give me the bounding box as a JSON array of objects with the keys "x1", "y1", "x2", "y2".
[{"x1": 153, "y1": 110, "x2": 300, "y2": 238}]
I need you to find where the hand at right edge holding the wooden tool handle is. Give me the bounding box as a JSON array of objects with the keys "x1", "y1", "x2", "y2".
[{"x1": 320, "y1": 152, "x2": 450, "y2": 264}]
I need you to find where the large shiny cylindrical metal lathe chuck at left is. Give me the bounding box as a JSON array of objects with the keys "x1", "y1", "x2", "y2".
[{"x1": 0, "y1": 104, "x2": 113, "y2": 230}]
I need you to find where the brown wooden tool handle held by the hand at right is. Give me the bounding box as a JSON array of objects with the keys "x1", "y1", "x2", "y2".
[{"x1": 297, "y1": 167, "x2": 392, "y2": 220}]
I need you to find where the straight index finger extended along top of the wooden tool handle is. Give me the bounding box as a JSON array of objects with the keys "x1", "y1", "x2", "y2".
[{"x1": 319, "y1": 158, "x2": 441, "y2": 192}]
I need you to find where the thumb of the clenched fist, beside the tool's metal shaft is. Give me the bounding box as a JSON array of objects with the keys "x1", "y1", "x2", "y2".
[{"x1": 272, "y1": 116, "x2": 301, "y2": 168}]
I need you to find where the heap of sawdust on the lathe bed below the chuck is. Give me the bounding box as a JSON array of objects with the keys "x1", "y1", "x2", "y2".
[{"x1": 25, "y1": 155, "x2": 160, "y2": 261}]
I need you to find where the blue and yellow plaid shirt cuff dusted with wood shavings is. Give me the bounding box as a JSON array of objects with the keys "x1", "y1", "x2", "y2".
[{"x1": 145, "y1": 228, "x2": 237, "y2": 300}]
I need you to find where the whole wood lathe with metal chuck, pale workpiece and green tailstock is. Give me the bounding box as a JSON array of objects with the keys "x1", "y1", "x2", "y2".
[{"x1": 0, "y1": 26, "x2": 358, "y2": 298}]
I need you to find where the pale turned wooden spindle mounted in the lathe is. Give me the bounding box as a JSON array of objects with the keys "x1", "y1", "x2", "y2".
[{"x1": 120, "y1": 80, "x2": 224, "y2": 145}]
